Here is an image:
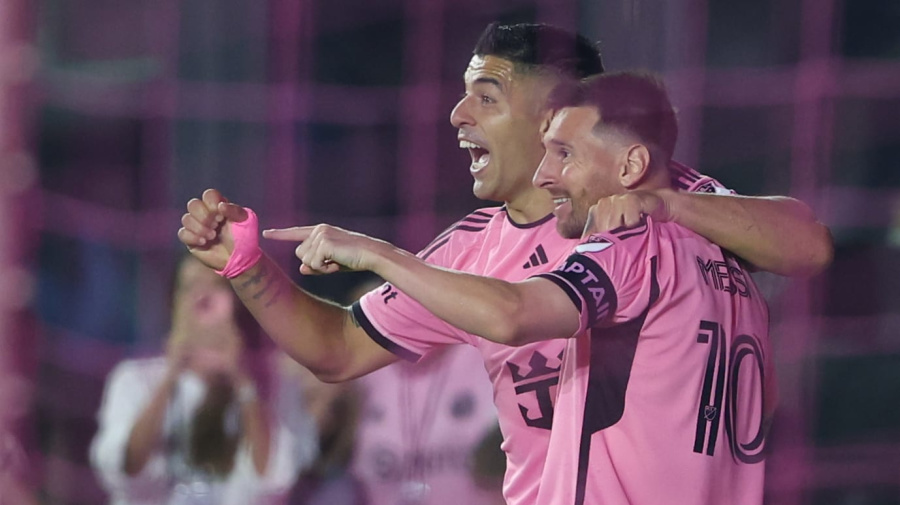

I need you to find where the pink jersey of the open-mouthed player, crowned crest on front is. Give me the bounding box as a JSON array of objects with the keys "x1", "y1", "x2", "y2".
[{"x1": 353, "y1": 164, "x2": 722, "y2": 505}]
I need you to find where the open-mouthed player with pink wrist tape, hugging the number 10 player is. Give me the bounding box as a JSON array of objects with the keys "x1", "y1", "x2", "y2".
[{"x1": 178, "y1": 25, "x2": 831, "y2": 505}]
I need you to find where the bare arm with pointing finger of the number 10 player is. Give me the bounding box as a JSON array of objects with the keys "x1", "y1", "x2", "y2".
[{"x1": 263, "y1": 225, "x2": 579, "y2": 345}]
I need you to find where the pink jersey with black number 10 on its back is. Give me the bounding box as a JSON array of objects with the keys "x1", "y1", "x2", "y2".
[{"x1": 537, "y1": 219, "x2": 775, "y2": 505}]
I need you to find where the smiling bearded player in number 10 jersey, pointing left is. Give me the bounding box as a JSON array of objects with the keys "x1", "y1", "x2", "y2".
[{"x1": 280, "y1": 74, "x2": 775, "y2": 505}]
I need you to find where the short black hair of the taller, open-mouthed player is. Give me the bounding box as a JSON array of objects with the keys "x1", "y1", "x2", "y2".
[{"x1": 472, "y1": 22, "x2": 603, "y2": 79}]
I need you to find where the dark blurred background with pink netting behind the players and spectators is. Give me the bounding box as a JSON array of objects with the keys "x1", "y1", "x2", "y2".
[{"x1": 0, "y1": 0, "x2": 900, "y2": 505}]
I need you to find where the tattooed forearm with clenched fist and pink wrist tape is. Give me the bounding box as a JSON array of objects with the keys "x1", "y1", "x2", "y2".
[{"x1": 178, "y1": 190, "x2": 397, "y2": 382}]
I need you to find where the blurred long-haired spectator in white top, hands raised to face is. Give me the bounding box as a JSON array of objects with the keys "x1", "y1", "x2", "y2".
[{"x1": 90, "y1": 256, "x2": 317, "y2": 505}]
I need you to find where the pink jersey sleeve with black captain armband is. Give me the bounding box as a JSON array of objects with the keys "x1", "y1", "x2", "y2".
[{"x1": 535, "y1": 220, "x2": 650, "y2": 335}]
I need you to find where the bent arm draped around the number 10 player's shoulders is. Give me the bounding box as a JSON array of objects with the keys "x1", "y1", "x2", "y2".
[{"x1": 585, "y1": 189, "x2": 834, "y2": 277}]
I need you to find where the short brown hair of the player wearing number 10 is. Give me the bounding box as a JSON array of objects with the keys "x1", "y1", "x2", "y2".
[{"x1": 549, "y1": 71, "x2": 678, "y2": 164}]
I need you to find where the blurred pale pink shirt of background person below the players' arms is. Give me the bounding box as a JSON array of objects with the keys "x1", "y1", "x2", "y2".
[{"x1": 351, "y1": 276, "x2": 503, "y2": 505}]
